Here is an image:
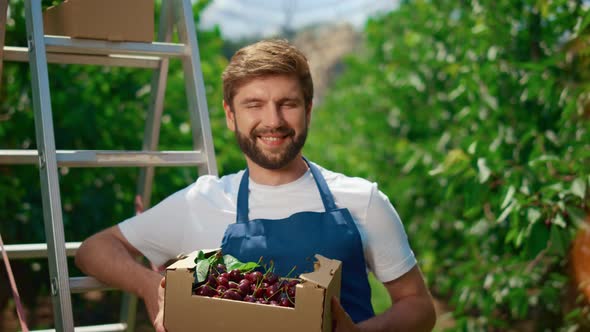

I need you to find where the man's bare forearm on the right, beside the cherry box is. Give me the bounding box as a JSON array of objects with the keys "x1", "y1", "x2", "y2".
[{"x1": 332, "y1": 265, "x2": 436, "y2": 332}]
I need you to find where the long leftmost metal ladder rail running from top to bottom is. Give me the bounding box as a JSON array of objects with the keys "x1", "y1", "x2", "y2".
[{"x1": 25, "y1": 0, "x2": 74, "y2": 331}]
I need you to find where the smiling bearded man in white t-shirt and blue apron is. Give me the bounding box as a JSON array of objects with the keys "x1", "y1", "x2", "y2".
[{"x1": 76, "y1": 40, "x2": 435, "y2": 331}]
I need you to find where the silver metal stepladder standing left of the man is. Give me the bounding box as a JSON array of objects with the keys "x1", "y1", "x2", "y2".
[{"x1": 0, "y1": 0, "x2": 217, "y2": 331}]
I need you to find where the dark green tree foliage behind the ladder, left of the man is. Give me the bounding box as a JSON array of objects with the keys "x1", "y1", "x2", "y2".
[{"x1": 0, "y1": 0, "x2": 243, "y2": 327}]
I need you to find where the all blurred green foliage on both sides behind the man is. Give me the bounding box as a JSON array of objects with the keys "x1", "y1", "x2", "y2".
[{"x1": 0, "y1": 0, "x2": 590, "y2": 331}]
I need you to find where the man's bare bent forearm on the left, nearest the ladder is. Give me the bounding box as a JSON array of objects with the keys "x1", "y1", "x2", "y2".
[{"x1": 76, "y1": 226, "x2": 162, "y2": 322}]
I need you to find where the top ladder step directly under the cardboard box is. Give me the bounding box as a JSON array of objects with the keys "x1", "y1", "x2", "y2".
[{"x1": 45, "y1": 36, "x2": 189, "y2": 57}]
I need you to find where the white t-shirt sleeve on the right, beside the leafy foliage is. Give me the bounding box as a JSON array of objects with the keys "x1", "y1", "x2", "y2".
[{"x1": 366, "y1": 184, "x2": 416, "y2": 282}]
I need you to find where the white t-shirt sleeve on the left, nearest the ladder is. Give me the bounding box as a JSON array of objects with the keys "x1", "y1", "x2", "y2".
[{"x1": 118, "y1": 186, "x2": 190, "y2": 266}]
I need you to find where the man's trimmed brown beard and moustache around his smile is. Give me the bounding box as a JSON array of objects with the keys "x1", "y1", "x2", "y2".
[{"x1": 235, "y1": 123, "x2": 307, "y2": 169}]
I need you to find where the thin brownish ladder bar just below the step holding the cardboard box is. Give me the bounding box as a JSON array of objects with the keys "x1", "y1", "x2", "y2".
[{"x1": 4, "y1": 46, "x2": 161, "y2": 69}]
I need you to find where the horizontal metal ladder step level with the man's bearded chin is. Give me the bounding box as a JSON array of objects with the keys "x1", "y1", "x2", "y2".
[{"x1": 0, "y1": 150, "x2": 207, "y2": 167}]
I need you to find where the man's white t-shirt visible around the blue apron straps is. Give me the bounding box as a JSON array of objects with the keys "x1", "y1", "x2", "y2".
[{"x1": 119, "y1": 164, "x2": 416, "y2": 282}]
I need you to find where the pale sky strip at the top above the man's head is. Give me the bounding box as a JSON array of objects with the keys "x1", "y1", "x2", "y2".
[{"x1": 201, "y1": 0, "x2": 398, "y2": 39}]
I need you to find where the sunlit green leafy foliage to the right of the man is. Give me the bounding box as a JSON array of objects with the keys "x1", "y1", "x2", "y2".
[{"x1": 306, "y1": 0, "x2": 590, "y2": 330}]
